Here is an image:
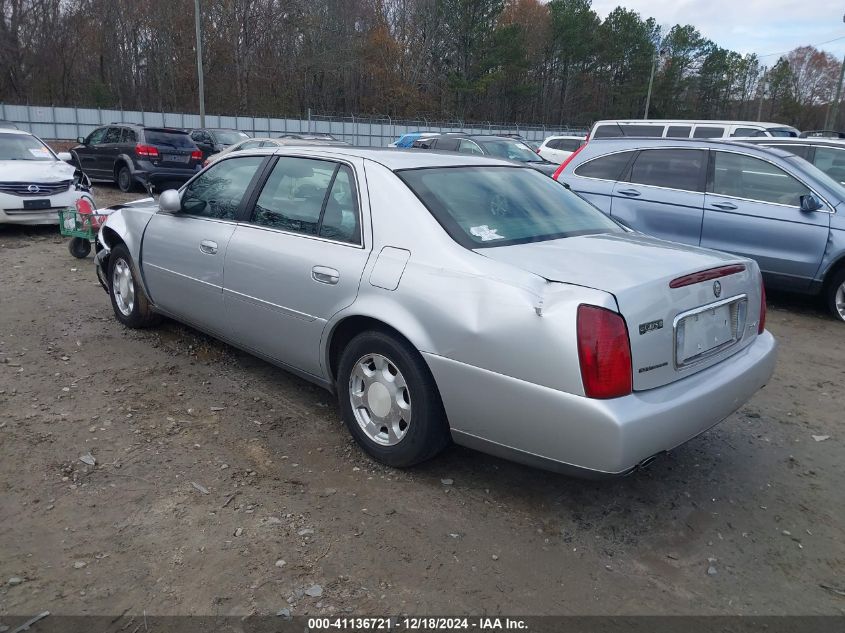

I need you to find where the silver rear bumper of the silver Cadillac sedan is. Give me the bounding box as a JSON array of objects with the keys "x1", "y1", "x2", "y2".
[{"x1": 424, "y1": 332, "x2": 777, "y2": 476}]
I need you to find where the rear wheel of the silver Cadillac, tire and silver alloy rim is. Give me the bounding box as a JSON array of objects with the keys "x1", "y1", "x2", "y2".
[{"x1": 337, "y1": 331, "x2": 450, "y2": 468}]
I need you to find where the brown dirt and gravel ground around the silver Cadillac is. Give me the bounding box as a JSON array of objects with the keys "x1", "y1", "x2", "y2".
[{"x1": 0, "y1": 186, "x2": 845, "y2": 622}]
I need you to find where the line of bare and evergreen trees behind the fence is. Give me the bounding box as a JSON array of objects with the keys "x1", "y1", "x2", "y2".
[{"x1": 0, "y1": 0, "x2": 845, "y2": 129}]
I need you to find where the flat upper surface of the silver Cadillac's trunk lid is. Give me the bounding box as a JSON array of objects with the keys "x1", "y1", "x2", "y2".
[{"x1": 477, "y1": 233, "x2": 742, "y2": 294}]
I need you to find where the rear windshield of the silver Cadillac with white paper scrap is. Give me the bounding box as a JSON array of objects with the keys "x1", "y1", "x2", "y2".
[{"x1": 397, "y1": 167, "x2": 623, "y2": 248}]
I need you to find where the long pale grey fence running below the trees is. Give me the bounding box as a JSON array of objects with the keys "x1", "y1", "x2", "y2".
[{"x1": 0, "y1": 104, "x2": 587, "y2": 147}]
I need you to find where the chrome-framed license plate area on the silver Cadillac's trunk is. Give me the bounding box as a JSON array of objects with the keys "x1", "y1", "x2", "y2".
[{"x1": 675, "y1": 298, "x2": 746, "y2": 367}]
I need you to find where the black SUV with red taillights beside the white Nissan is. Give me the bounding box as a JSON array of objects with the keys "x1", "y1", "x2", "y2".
[{"x1": 70, "y1": 123, "x2": 202, "y2": 192}]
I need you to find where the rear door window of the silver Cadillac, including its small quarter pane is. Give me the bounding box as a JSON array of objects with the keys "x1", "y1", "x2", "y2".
[{"x1": 252, "y1": 156, "x2": 360, "y2": 243}]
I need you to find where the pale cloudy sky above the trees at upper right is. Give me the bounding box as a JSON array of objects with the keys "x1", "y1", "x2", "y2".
[{"x1": 593, "y1": 0, "x2": 845, "y2": 61}]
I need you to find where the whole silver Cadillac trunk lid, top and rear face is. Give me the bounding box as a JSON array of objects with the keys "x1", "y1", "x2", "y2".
[{"x1": 476, "y1": 234, "x2": 760, "y2": 391}]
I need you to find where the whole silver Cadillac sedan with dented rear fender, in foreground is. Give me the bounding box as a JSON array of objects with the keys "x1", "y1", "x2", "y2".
[{"x1": 96, "y1": 147, "x2": 776, "y2": 475}]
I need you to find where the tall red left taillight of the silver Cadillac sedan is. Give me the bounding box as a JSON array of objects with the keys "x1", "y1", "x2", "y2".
[{"x1": 576, "y1": 305, "x2": 633, "y2": 399}]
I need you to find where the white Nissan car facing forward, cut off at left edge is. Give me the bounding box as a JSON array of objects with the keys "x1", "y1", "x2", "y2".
[{"x1": 0, "y1": 128, "x2": 85, "y2": 224}]
